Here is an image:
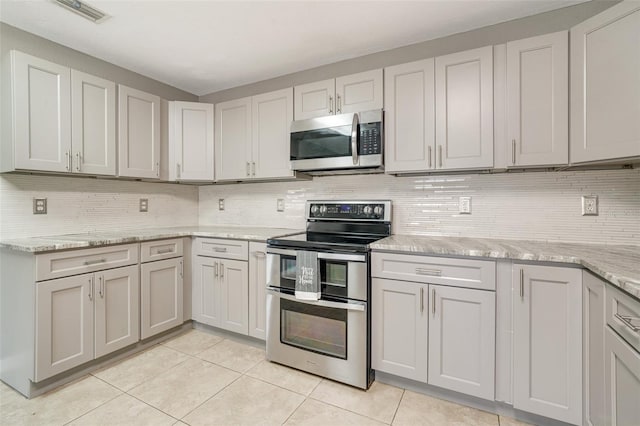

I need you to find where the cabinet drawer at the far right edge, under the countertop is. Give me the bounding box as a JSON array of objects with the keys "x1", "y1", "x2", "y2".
[{"x1": 606, "y1": 285, "x2": 640, "y2": 352}]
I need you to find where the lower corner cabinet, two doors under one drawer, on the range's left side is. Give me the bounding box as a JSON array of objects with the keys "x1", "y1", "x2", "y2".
[{"x1": 192, "y1": 239, "x2": 249, "y2": 334}]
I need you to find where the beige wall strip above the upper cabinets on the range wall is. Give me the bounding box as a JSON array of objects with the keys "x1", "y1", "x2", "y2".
[{"x1": 200, "y1": 0, "x2": 618, "y2": 103}]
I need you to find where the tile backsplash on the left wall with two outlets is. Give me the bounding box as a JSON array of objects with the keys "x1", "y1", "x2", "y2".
[{"x1": 0, "y1": 174, "x2": 198, "y2": 239}]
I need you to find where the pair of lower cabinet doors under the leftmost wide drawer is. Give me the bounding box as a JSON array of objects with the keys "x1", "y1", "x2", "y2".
[{"x1": 34, "y1": 265, "x2": 139, "y2": 382}]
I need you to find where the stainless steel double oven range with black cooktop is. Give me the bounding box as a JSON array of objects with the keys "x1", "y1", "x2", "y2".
[{"x1": 267, "y1": 200, "x2": 391, "y2": 389}]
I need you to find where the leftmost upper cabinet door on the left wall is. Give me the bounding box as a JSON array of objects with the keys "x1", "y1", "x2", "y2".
[{"x1": 11, "y1": 50, "x2": 71, "y2": 172}]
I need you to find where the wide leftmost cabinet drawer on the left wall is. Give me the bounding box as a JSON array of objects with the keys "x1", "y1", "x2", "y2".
[{"x1": 36, "y1": 244, "x2": 139, "y2": 281}]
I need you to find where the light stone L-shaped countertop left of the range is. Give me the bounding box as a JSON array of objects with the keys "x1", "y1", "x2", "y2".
[{"x1": 0, "y1": 225, "x2": 304, "y2": 253}]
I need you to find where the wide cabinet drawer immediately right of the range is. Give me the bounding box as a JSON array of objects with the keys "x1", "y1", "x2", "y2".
[{"x1": 371, "y1": 252, "x2": 496, "y2": 290}]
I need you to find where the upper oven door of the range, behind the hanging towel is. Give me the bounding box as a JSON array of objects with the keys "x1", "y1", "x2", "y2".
[{"x1": 267, "y1": 248, "x2": 367, "y2": 300}]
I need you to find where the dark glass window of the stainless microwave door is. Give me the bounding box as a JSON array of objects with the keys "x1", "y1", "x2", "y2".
[{"x1": 291, "y1": 126, "x2": 351, "y2": 160}]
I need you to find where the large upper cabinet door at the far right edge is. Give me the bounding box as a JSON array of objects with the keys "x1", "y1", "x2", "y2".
[{"x1": 571, "y1": 1, "x2": 640, "y2": 163}]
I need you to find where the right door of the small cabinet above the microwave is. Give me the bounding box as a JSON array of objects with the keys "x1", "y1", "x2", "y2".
[{"x1": 336, "y1": 69, "x2": 384, "y2": 114}]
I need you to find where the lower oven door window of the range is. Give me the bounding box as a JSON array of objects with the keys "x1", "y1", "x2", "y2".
[{"x1": 280, "y1": 299, "x2": 347, "y2": 359}]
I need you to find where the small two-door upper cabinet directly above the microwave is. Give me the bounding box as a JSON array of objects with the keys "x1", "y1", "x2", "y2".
[{"x1": 294, "y1": 69, "x2": 383, "y2": 120}]
